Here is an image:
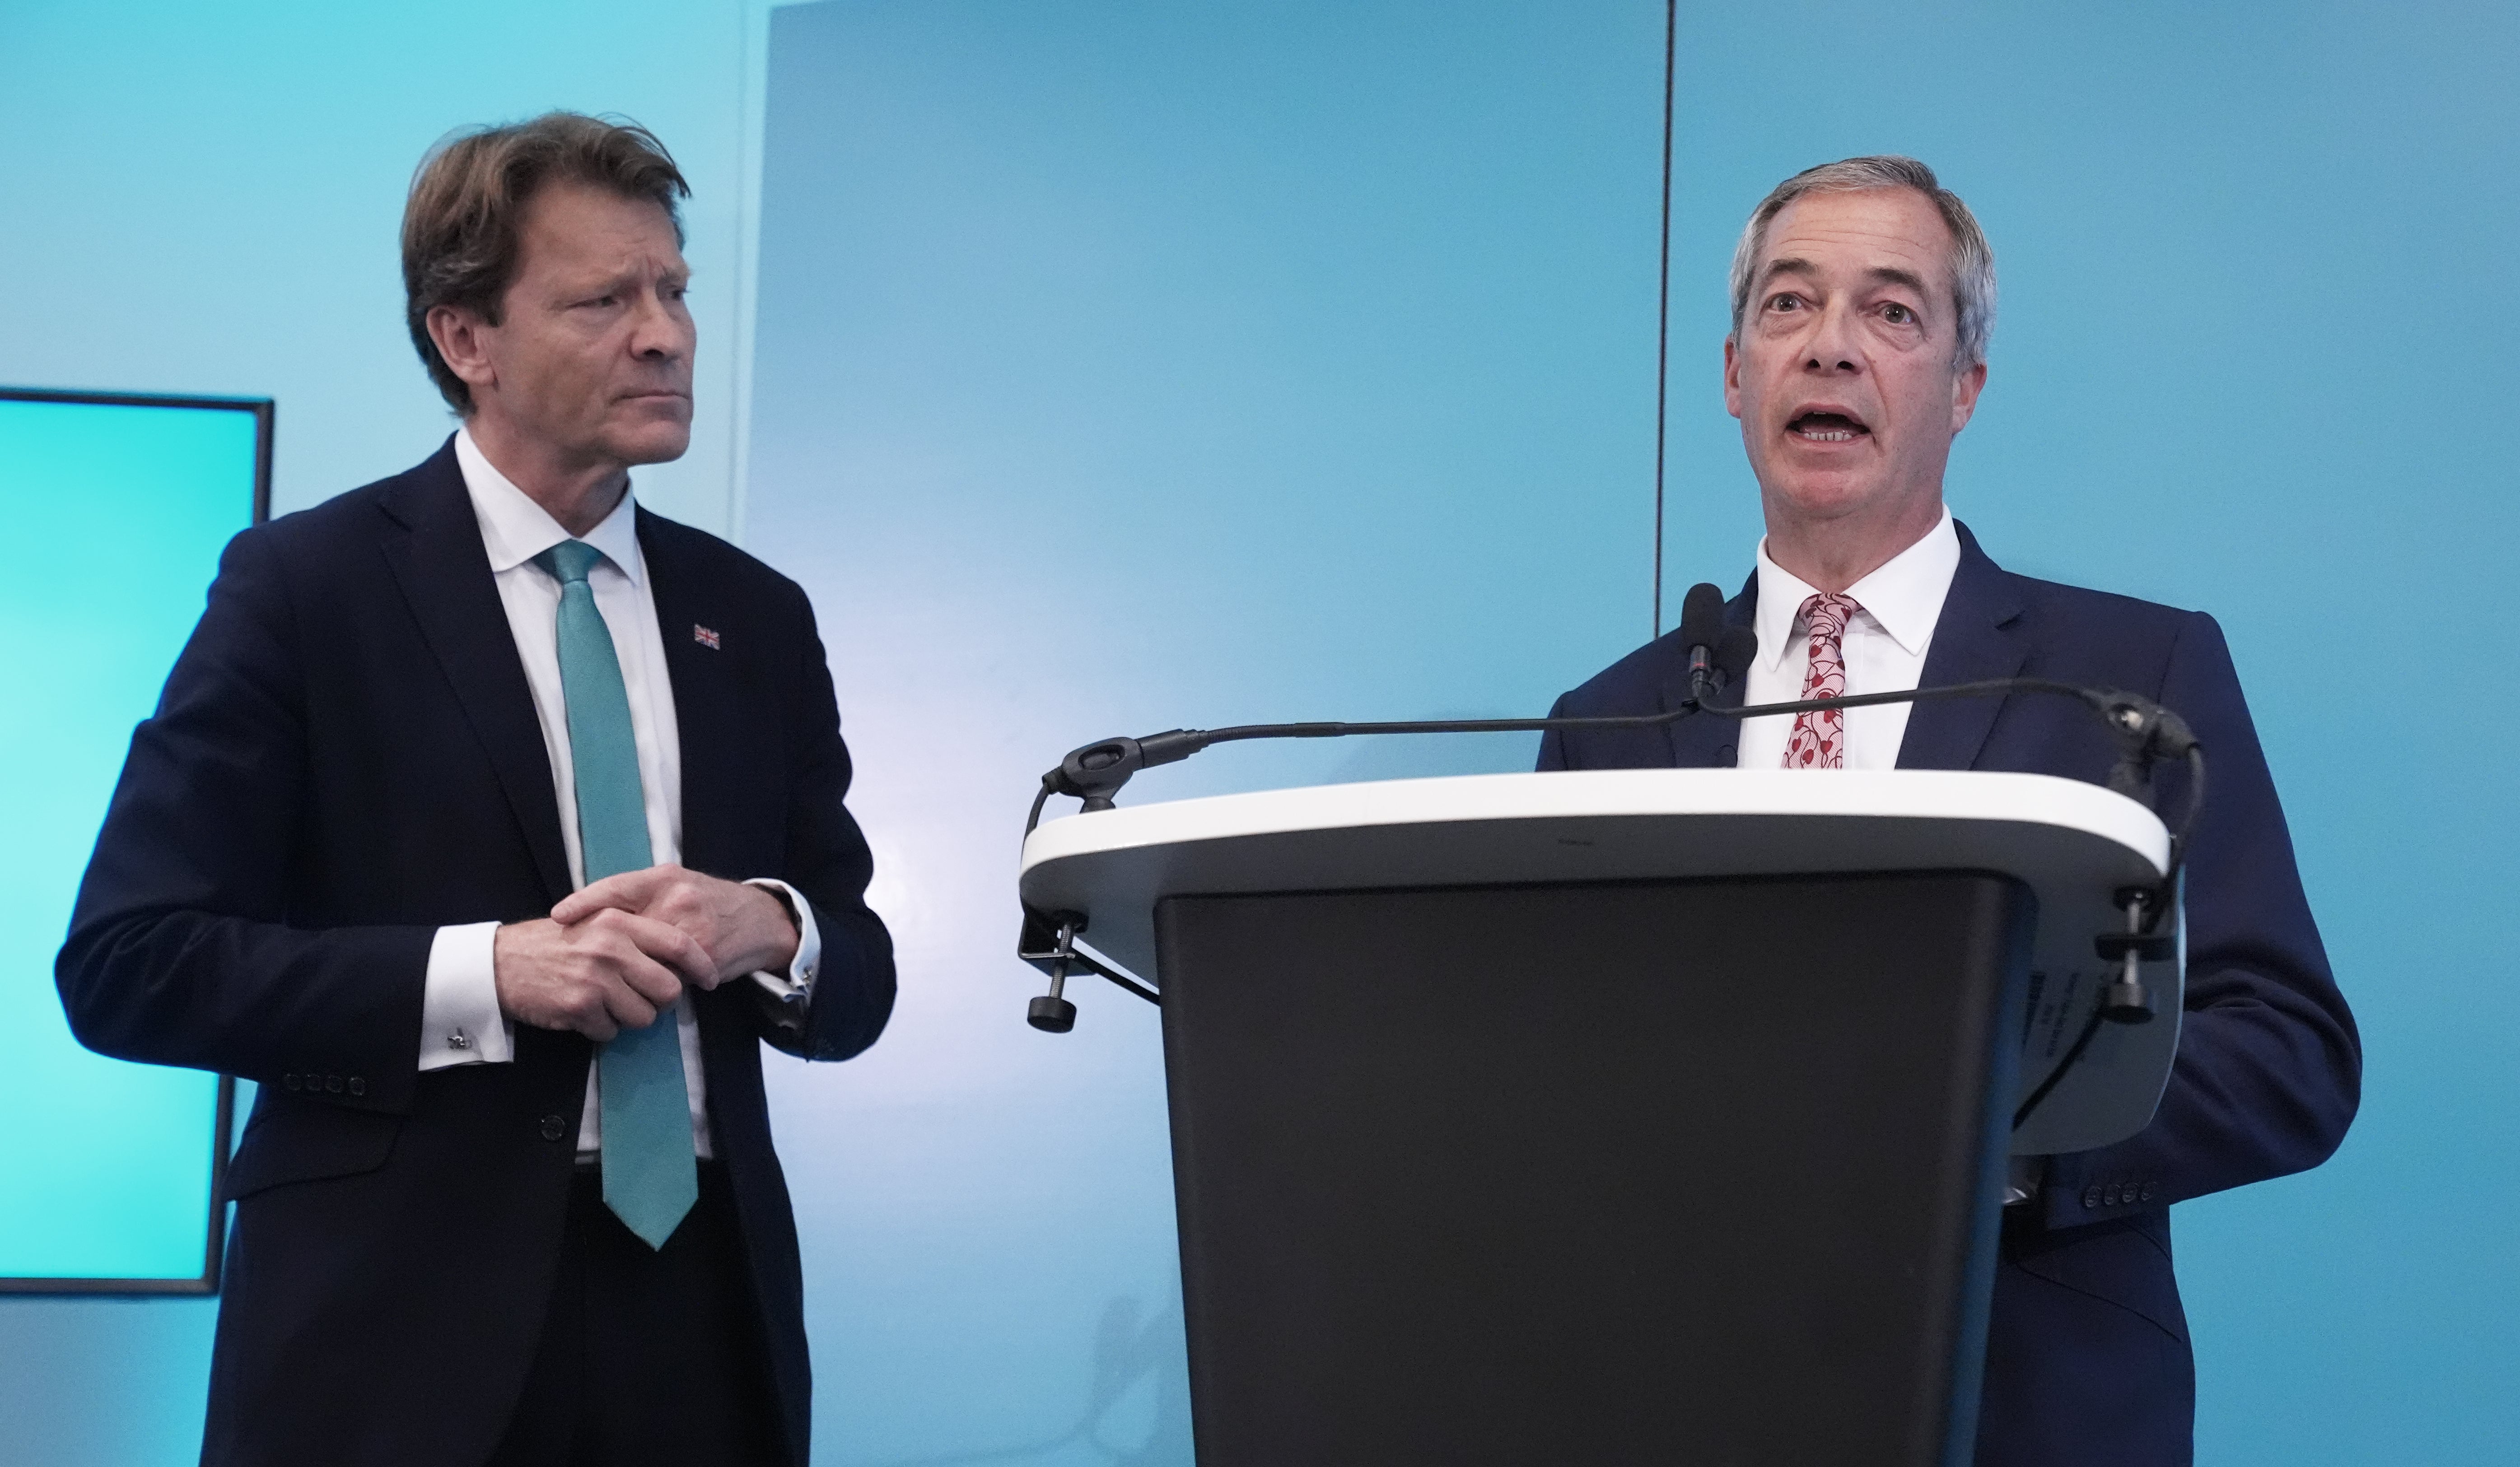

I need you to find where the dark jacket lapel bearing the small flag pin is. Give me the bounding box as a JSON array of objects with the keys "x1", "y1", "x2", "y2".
[{"x1": 638, "y1": 509, "x2": 736, "y2": 875}]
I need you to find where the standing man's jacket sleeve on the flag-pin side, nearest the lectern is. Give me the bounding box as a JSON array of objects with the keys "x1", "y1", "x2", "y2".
[{"x1": 756, "y1": 587, "x2": 895, "y2": 1059}]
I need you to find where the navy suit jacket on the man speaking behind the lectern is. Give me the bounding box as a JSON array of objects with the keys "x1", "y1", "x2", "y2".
[{"x1": 1540, "y1": 527, "x2": 2361, "y2": 1467}]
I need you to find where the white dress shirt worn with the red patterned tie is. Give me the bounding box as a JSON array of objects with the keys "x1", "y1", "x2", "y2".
[{"x1": 1736, "y1": 509, "x2": 1960, "y2": 769}]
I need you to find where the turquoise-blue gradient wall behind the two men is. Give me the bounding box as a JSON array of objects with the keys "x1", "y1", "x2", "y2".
[{"x1": 0, "y1": 0, "x2": 2520, "y2": 1467}]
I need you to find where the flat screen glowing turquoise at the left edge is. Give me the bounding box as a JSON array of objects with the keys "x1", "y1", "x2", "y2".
[{"x1": 0, "y1": 388, "x2": 272, "y2": 1293}]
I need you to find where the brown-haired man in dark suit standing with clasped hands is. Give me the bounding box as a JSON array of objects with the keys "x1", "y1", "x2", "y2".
[{"x1": 58, "y1": 113, "x2": 895, "y2": 1467}]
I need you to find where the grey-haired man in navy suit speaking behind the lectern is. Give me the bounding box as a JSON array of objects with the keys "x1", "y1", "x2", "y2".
[{"x1": 1540, "y1": 159, "x2": 2361, "y2": 1467}]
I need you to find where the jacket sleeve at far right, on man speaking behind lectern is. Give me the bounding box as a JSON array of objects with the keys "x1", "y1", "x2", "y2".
[{"x1": 2041, "y1": 615, "x2": 2361, "y2": 1228}]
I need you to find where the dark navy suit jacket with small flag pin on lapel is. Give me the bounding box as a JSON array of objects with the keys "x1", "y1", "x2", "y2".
[{"x1": 56, "y1": 441, "x2": 892, "y2": 1467}]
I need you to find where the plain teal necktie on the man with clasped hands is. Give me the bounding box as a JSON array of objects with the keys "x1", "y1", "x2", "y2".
[{"x1": 534, "y1": 540, "x2": 700, "y2": 1248}]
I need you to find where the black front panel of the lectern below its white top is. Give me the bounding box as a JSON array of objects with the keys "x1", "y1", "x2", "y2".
[{"x1": 1154, "y1": 872, "x2": 2034, "y2": 1467}]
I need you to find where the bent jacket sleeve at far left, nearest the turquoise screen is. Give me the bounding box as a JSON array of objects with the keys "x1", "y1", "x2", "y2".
[{"x1": 53, "y1": 529, "x2": 436, "y2": 1112}]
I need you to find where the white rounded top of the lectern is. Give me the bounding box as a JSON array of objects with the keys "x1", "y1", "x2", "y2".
[{"x1": 1021, "y1": 769, "x2": 2182, "y2": 1152}]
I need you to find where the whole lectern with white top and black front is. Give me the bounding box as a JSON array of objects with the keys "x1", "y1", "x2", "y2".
[{"x1": 1023, "y1": 771, "x2": 2177, "y2": 1467}]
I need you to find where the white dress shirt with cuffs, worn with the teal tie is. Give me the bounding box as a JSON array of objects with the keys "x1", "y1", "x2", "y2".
[{"x1": 421, "y1": 428, "x2": 821, "y2": 1157}]
